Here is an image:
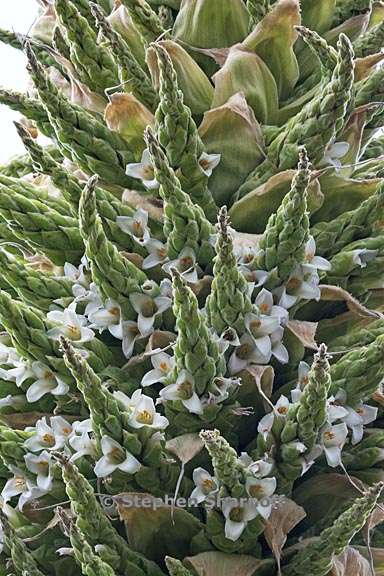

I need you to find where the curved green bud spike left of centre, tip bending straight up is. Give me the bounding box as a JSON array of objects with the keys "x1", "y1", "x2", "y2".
[{"x1": 79, "y1": 178, "x2": 147, "y2": 320}]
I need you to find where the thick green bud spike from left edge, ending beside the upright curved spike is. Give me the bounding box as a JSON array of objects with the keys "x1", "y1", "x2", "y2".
[{"x1": 0, "y1": 186, "x2": 84, "y2": 265}]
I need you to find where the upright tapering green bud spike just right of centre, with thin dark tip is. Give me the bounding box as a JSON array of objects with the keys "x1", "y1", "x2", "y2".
[{"x1": 206, "y1": 207, "x2": 254, "y2": 336}]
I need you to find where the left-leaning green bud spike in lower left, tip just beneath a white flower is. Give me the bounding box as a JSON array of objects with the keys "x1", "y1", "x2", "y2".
[{"x1": 60, "y1": 337, "x2": 124, "y2": 445}]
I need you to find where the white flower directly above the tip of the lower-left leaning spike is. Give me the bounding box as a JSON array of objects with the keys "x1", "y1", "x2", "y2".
[{"x1": 47, "y1": 302, "x2": 95, "y2": 344}]
